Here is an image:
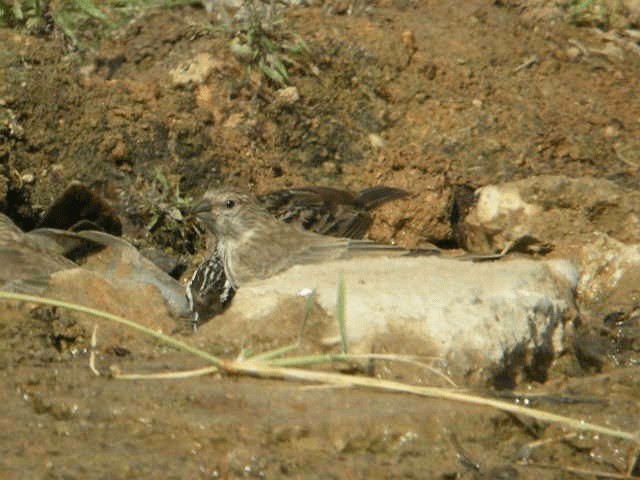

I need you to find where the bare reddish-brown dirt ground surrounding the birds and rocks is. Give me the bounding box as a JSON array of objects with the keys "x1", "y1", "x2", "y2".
[{"x1": 0, "y1": 0, "x2": 640, "y2": 479}]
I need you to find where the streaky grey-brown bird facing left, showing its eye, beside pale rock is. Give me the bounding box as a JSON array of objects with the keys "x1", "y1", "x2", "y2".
[{"x1": 194, "y1": 189, "x2": 406, "y2": 289}]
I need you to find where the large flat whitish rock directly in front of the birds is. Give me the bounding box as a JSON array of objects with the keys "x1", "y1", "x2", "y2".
[{"x1": 201, "y1": 257, "x2": 578, "y2": 383}]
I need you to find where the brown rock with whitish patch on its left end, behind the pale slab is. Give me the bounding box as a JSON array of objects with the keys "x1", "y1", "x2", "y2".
[{"x1": 462, "y1": 176, "x2": 640, "y2": 253}]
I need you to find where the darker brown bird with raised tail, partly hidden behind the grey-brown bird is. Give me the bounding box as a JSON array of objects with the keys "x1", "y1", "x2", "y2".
[{"x1": 256, "y1": 186, "x2": 409, "y2": 238}]
